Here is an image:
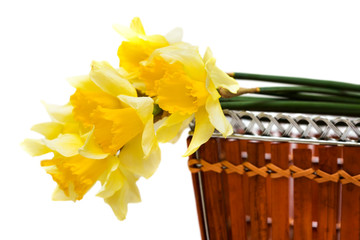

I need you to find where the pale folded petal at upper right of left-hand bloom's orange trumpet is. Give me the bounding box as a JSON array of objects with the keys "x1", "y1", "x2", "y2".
[{"x1": 118, "y1": 95, "x2": 154, "y2": 124}]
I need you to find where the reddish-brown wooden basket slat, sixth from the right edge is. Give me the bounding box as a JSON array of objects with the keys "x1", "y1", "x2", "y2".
[{"x1": 221, "y1": 139, "x2": 246, "y2": 240}]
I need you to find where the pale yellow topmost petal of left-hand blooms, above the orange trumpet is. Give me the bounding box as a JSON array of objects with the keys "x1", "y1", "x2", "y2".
[{"x1": 89, "y1": 61, "x2": 137, "y2": 97}]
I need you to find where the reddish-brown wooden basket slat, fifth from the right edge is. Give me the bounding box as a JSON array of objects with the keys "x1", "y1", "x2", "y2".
[{"x1": 247, "y1": 142, "x2": 268, "y2": 240}]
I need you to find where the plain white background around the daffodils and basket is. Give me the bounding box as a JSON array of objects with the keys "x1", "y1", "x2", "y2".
[{"x1": 0, "y1": 0, "x2": 360, "y2": 240}]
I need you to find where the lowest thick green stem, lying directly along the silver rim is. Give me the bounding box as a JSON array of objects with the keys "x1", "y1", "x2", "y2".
[{"x1": 220, "y1": 97, "x2": 360, "y2": 117}]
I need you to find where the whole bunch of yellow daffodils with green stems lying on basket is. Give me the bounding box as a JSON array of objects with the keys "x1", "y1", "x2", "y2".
[{"x1": 22, "y1": 18, "x2": 360, "y2": 220}]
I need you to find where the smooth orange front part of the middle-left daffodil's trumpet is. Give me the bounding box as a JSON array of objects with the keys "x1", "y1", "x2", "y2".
[{"x1": 93, "y1": 107, "x2": 144, "y2": 154}]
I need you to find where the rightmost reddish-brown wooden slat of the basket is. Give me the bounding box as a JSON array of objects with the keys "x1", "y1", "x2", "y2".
[{"x1": 340, "y1": 147, "x2": 360, "y2": 240}]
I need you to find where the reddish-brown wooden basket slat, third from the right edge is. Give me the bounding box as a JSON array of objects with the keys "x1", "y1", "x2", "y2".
[{"x1": 293, "y1": 149, "x2": 312, "y2": 240}]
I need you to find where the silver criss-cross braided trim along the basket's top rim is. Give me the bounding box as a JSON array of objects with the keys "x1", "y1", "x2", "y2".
[{"x1": 190, "y1": 109, "x2": 360, "y2": 145}]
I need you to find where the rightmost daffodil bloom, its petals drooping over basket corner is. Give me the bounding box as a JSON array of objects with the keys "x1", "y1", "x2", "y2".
[{"x1": 140, "y1": 43, "x2": 239, "y2": 156}]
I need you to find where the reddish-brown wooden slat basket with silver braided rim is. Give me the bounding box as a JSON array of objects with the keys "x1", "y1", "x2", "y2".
[{"x1": 188, "y1": 111, "x2": 360, "y2": 240}]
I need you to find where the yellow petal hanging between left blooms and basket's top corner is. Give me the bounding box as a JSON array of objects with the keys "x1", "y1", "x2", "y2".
[{"x1": 156, "y1": 113, "x2": 193, "y2": 142}]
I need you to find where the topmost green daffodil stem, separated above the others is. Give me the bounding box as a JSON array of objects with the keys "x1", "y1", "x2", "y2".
[{"x1": 229, "y1": 72, "x2": 360, "y2": 92}]
